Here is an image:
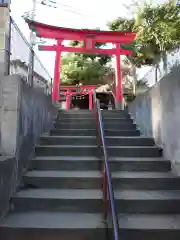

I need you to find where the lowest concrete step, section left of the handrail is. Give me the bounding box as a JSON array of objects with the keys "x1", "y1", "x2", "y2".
[{"x1": 0, "y1": 211, "x2": 105, "y2": 240}]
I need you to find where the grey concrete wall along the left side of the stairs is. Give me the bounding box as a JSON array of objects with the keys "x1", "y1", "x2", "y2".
[{"x1": 0, "y1": 75, "x2": 56, "y2": 217}]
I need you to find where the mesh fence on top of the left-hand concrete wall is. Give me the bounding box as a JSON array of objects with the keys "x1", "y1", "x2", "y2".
[{"x1": 10, "y1": 18, "x2": 52, "y2": 91}]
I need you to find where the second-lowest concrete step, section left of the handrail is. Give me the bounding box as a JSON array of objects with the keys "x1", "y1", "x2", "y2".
[{"x1": 13, "y1": 189, "x2": 103, "y2": 213}]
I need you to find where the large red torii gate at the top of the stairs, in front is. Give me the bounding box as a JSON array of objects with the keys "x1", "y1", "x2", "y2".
[{"x1": 26, "y1": 19, "x2": 136, "y2": 107}]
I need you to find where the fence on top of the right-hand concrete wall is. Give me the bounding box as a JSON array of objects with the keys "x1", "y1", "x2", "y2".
[{"x1": 142, "y1": 48, "x2": 180, "y2": 86}]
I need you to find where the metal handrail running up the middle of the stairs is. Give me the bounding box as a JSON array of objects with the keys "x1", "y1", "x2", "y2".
[{"x1": 93, "y1": 90, "x2": 119, "y2": 240}]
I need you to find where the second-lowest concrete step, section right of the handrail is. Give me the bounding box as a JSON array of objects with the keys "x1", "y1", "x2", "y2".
[{"x1": 115, "y1": 190, "x2": 180, "y2": 214}]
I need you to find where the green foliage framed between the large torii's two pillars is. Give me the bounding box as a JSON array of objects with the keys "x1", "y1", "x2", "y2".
[{"x1": 61, "y1": 41, "x2": 111, "y2": 84}]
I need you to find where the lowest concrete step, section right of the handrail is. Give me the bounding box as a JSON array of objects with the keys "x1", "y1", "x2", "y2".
[{"x1": 119, "y1": 214, "x2": 180, "y2": 240}]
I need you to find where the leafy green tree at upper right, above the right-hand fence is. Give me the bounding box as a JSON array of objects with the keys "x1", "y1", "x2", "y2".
[{"x1": 108, "y1": 1, "x2": 180, "y2": 66}]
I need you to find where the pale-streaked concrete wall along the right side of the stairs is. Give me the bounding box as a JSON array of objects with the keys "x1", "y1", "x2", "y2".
[{"x1": 129, "y1": 66, "x2": 180, "y2": 174}]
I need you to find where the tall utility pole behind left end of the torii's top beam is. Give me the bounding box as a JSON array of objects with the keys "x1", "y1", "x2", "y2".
[{"x1": 28, "y1": 0, "x2": 36, "y2": 87}]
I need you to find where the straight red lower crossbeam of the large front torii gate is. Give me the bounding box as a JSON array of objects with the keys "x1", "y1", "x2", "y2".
[{"x1": 39, "y1": 45, "x2": 132, "y2": 55}]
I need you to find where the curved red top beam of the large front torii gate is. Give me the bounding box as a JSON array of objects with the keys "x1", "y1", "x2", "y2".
[{"x1": 26, "y1": 19, "x2": 136, "y2": 40}]
